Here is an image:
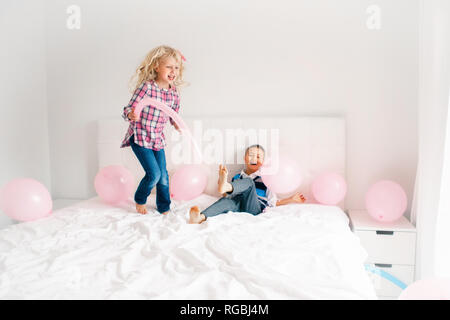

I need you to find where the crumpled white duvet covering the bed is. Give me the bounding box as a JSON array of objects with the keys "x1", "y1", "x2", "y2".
[{"x1": 0, "y1": 195, "x2": 376, "y2": 299}]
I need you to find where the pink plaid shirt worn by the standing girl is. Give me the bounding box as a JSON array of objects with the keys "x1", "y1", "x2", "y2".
[{"x1": 120, "y1": 80, "x2": 180, "y2": 151}]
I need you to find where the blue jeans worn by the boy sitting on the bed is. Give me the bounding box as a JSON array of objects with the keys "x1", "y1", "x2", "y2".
[{"x1": 201, "y1": 178, "x2": 264, "y2": 218}]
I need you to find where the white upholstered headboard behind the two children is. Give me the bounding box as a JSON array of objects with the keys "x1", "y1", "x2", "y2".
[{"x1": 97, "y1": 116, "x2": 346, "y2": 209}]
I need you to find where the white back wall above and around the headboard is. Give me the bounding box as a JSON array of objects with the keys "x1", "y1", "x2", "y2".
[{"x1": 43, "y1": 0, "x2": 419, "y2": 215}]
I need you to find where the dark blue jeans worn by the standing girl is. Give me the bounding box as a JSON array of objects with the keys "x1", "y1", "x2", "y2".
[{"x1": 130, "y1": 136, "x2": 170, "y2": 213}]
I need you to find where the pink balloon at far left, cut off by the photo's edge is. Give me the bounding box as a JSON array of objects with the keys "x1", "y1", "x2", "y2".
[{"x1": 0, "y1": 178, "x2": 53, "y2": 221}]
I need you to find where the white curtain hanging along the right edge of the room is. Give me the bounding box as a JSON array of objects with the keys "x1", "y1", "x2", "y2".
[{"x1": 412, "y1": 0, "x2": 450, "y2": 279}]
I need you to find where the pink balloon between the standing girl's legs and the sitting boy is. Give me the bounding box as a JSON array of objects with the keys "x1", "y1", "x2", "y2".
[{"x1": 170, "y1": 164, "x2": 208, "y2": 200}]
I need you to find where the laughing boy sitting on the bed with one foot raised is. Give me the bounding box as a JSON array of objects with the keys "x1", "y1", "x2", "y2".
[{"x1": 189, "y1": 145, "x2": 305, "y2": 224}]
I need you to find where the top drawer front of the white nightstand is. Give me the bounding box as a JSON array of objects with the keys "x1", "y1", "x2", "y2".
[{"x1": 355, "y1": 230, "x2": 416, "y2": 265}]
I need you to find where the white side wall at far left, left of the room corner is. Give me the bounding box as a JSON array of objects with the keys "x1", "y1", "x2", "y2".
[{"x1": 0, "y1": 0, "x2": 50, "y2": 228}]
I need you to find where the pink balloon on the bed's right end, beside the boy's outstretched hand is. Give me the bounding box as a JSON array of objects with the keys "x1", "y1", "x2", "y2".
[{"x1": 311, "y1": 173, "x2": 347, "y2": 205}]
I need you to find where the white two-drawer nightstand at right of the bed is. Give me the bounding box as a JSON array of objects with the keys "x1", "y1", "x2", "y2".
[{"x1": 348, "y1": 210, "x2": 416, "y2": 299}]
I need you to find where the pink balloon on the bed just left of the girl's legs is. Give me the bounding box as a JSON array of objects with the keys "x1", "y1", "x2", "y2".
[{"x1": 94, "y1": 165, "x2": 135, "y2": 205}]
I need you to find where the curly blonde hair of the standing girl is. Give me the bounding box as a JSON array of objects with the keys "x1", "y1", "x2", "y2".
[{"x1": 130, "y1": 45, "x2": 187, "y2": 92}]
